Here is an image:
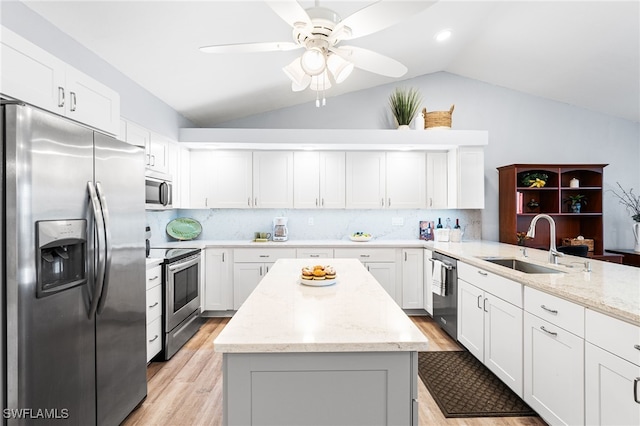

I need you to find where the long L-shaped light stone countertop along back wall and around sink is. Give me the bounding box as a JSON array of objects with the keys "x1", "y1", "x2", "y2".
[{"x1": 155, "y1": 238, "x2": 640, "y2": 326}]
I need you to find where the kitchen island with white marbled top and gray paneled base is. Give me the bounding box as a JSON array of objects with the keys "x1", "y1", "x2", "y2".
[{"x1": 214, "y1": 259, "x2": 428, "y2": 425}]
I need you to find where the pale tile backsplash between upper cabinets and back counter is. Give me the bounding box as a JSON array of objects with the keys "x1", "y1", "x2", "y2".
[{"x1": 147, "y1": 209, "x2": 482, "y2": 246}]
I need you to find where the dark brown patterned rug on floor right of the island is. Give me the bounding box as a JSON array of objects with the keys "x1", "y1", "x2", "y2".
[{"x1": 418, "y1": 351, "x2": 537, "y2": 417}]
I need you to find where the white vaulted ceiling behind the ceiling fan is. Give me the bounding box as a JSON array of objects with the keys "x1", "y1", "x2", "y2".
[{"x1": 24, "y1": 0, "x2": 640, "y2": 127}]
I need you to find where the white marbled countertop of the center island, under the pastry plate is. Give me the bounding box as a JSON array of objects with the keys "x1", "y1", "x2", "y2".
[{"x1": 214, "y1": 259, "x2": 428, "y2": 353}]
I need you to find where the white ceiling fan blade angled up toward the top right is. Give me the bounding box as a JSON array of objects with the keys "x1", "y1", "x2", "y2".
[{"x1": 332, "y1": 0, "x2": 437, "y2": 41}]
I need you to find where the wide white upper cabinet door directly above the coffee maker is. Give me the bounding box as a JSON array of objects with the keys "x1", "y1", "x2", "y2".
[{"x1": 253, "y1": 151, "x2": 293, "y2": 209}]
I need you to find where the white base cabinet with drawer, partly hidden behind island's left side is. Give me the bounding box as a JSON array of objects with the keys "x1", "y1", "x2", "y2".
[{"x1": 233, "y1": 248, "x2": 296, "y2": 310}]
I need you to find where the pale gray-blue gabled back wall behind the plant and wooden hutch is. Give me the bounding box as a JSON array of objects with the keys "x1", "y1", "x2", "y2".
[{"x1": 221, "y1": 72, "x2": 640, "y2": 248}]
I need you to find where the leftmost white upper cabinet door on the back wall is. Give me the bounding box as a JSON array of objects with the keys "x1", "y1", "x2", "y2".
[{"x1": 189, "y1": 151, "x2": 216, "y2": 209}]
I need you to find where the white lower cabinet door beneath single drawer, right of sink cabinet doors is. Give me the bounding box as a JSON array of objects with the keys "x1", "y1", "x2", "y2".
[{"x1": 524, "y1": 312, "x2": 584, "y2": 425}]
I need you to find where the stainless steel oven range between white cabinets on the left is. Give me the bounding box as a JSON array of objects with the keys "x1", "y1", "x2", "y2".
[{"x1": 150, "y1": 249, "x2": 202, "y2": 360}]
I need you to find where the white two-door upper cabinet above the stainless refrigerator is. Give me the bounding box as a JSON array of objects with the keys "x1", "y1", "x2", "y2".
[{"x1": 0, "y1": 27, "x2": 120, "y2": 135}]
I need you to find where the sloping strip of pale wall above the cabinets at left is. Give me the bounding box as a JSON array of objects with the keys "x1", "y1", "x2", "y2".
[{"x1": 0, "y1": 0, "x2": 194, "y2": 140}]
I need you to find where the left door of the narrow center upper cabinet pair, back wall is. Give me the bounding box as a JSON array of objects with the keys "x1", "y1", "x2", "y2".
[{"x1": 293, "y1": 151, "x2": 320, "y2": 209}]
